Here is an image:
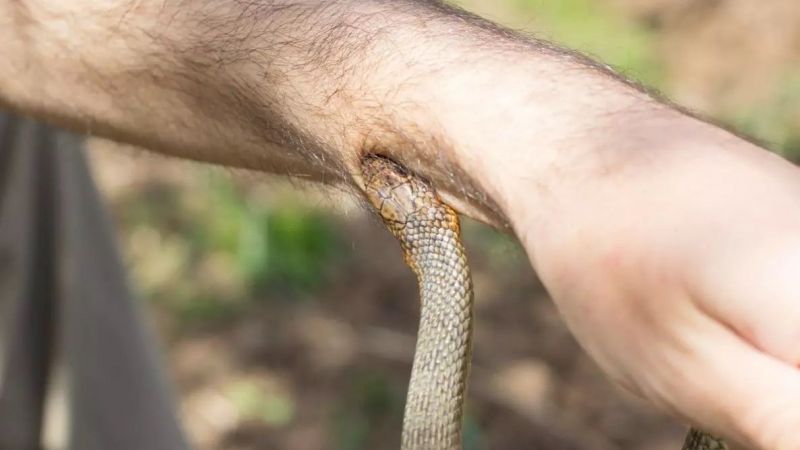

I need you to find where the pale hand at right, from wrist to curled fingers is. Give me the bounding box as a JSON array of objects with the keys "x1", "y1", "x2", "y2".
[{"x1": 500, "y1": 123, "x2": 800, "y2": 450}]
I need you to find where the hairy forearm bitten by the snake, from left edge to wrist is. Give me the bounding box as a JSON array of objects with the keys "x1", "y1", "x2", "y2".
[{"x1": 0, "y1": 0, "x2": 736, "y2": 230}]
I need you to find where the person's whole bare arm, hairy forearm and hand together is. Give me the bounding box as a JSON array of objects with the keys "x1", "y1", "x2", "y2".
[{"x1": 0, "y1": 0, "x2": 800, "y2": 450}]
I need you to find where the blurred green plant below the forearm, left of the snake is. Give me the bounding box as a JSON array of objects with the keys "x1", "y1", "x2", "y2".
[{"x1": 119, "y1": 169, "x2": 345, "y2": 324}]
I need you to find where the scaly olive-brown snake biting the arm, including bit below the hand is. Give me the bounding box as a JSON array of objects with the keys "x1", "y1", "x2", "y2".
[{"x1": 361, "y1": 154, "x2": 728, "y2": 450}]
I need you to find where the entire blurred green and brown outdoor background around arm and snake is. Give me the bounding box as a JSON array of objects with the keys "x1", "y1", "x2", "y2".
[{"x1": 84, "y1": 0, "x2": 800, "y2": 450}]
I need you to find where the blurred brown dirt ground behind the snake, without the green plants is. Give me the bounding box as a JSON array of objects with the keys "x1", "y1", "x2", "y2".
[{"x1": 87, "y1": 0, "x2": 800, "y2": 450}]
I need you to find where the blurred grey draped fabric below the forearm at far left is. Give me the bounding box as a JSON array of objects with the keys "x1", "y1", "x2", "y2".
[{"x1": 0, "y1": 114, "x2": 188, "y2": 450}]
